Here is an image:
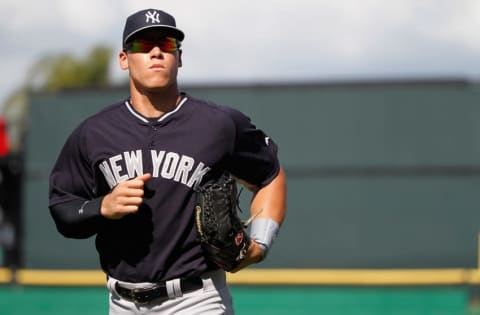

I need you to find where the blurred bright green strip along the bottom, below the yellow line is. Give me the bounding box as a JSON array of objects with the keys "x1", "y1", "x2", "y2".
[{"x1": 0, "y1": 285, "x2": 472, "y2": 315}]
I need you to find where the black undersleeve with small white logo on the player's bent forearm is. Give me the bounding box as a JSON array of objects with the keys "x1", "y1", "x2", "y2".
[{"x1": 50, "y1": 198, "x2": 103, "y2": 238}]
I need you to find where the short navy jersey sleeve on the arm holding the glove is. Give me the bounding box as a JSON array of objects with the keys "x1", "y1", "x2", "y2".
[{"x1": 222, "y1": 108, "x2": 280, "y2": 188}]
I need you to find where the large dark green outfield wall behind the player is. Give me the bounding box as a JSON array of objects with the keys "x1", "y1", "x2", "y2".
[{"x1": 22, "y1": 81, "x2": 480, "y2": 270}]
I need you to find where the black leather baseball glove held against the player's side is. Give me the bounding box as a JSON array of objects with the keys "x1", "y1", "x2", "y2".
[{"x1": 195, "y1": 173, "x2": 251, "y2": 271}]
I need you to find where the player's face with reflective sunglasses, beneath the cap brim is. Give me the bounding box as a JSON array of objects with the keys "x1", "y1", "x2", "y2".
[{"x1": 119, "y1": 30, "x2": 181, "y2": 92}]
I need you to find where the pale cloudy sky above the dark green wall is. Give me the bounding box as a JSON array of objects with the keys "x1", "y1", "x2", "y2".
[{"x1": 0, "y1": 0, "x2": 480, "y2": 103}]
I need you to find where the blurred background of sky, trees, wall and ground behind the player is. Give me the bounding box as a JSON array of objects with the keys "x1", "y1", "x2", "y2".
[{"x1": 0, "y1": 0, "x2": 480, "y2": 315}]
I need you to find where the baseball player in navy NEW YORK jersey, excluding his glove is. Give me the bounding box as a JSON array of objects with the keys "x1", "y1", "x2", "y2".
[{"x1": 49, "y1": 9, "x2": 286, "y2": 315}]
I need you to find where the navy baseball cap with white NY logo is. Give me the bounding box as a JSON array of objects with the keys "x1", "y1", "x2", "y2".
[{"x1": 123, "y1": 9, "x2": 185, "y2": 47}]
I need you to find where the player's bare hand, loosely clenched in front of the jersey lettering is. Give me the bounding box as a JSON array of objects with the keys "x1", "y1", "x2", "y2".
[{"x1": 101, "y1": 173, "x2": 152, "y2": 220}]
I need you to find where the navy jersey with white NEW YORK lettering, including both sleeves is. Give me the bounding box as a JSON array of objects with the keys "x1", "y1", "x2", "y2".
[{"x1": 49, "y1": 94, "x2": 280, "y2": 282}]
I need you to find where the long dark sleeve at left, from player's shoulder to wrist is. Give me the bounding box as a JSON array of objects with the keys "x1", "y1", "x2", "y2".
[{"x1": 49, "y1": 122, "x2": 103, "y2": 238}]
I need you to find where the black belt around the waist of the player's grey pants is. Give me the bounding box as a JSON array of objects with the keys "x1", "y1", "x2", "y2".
[{"x1": 115, "y1": 277, "x2": 203, "y2": 304}]
